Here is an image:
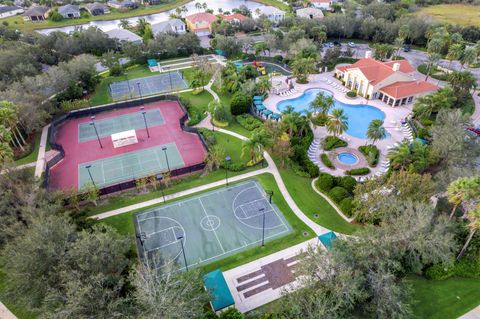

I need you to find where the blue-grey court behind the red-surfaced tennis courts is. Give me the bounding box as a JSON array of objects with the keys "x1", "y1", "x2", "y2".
[{"x1": 109, "y1": 71, "x2": 188, "y2": 101}]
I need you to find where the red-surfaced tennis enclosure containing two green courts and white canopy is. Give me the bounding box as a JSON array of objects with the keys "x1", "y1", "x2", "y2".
[{"x1": 49, "y1": 101, "x2": 206, "y2": 189}]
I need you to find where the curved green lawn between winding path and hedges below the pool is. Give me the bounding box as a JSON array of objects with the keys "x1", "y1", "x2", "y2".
[{"x1": 277, "y1": 161, "x2": 359, "y2": 234}]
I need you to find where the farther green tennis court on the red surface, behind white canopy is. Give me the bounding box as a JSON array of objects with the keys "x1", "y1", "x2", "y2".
[{"x1": 78, "y1": 109, "x2": 165, "y2": 143}]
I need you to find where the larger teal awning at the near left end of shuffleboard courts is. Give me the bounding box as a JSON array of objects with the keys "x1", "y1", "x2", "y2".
[{"x1": 203, "y1": 269, "x2": 235, "y2": 311}]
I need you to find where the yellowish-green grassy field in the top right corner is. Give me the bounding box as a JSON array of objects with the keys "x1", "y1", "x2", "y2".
[{"x1": 417, "y1": 4, "x2": 480, "y2": 27}]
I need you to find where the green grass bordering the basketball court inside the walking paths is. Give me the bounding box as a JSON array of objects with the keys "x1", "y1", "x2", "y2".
[{"x1": 102, "y1": 173, "x2": 315, "y2": 272}]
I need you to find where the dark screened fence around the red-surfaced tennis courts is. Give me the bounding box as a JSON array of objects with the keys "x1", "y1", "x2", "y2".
[{"x1": 43, "y1": 95, "x2": 208, "y2": 195}]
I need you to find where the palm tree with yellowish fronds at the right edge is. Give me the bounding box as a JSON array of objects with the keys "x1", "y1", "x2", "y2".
[{"x1": 447, "y1": 176, "x2": 480, "y2": 220}]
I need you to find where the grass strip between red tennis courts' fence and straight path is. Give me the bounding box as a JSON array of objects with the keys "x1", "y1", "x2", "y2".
[{"x1": 85, "y1": 132, "x2": 262, "y2": 216}]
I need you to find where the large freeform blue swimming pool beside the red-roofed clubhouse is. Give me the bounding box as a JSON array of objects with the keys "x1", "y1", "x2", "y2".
[{"x1": 277, "y1": 89, "x2": 390, "y2": 139}]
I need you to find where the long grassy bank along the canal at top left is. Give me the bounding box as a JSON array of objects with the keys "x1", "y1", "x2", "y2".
[{"x1": 2, "y1": 0, "x2": 191, "y2": 31}]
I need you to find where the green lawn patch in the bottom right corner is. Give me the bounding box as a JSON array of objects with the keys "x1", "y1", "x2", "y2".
[{"x1": 406, "y1": 276, "x2": 480, "y2": 319}]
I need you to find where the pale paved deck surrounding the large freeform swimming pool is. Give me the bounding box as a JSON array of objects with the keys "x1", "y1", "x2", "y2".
[{"x1": 264, "y1": 72, "x2": 413, "y2": 176}]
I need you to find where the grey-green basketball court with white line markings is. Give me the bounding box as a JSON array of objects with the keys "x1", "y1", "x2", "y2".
[{"x1": 134, "y1": 180, "x2": 292, "y2": 269}]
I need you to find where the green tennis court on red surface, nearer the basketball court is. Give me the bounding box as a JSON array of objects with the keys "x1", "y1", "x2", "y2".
[{"x1": 78, "y1": 143, "x2": 185, "y2": 189}]
